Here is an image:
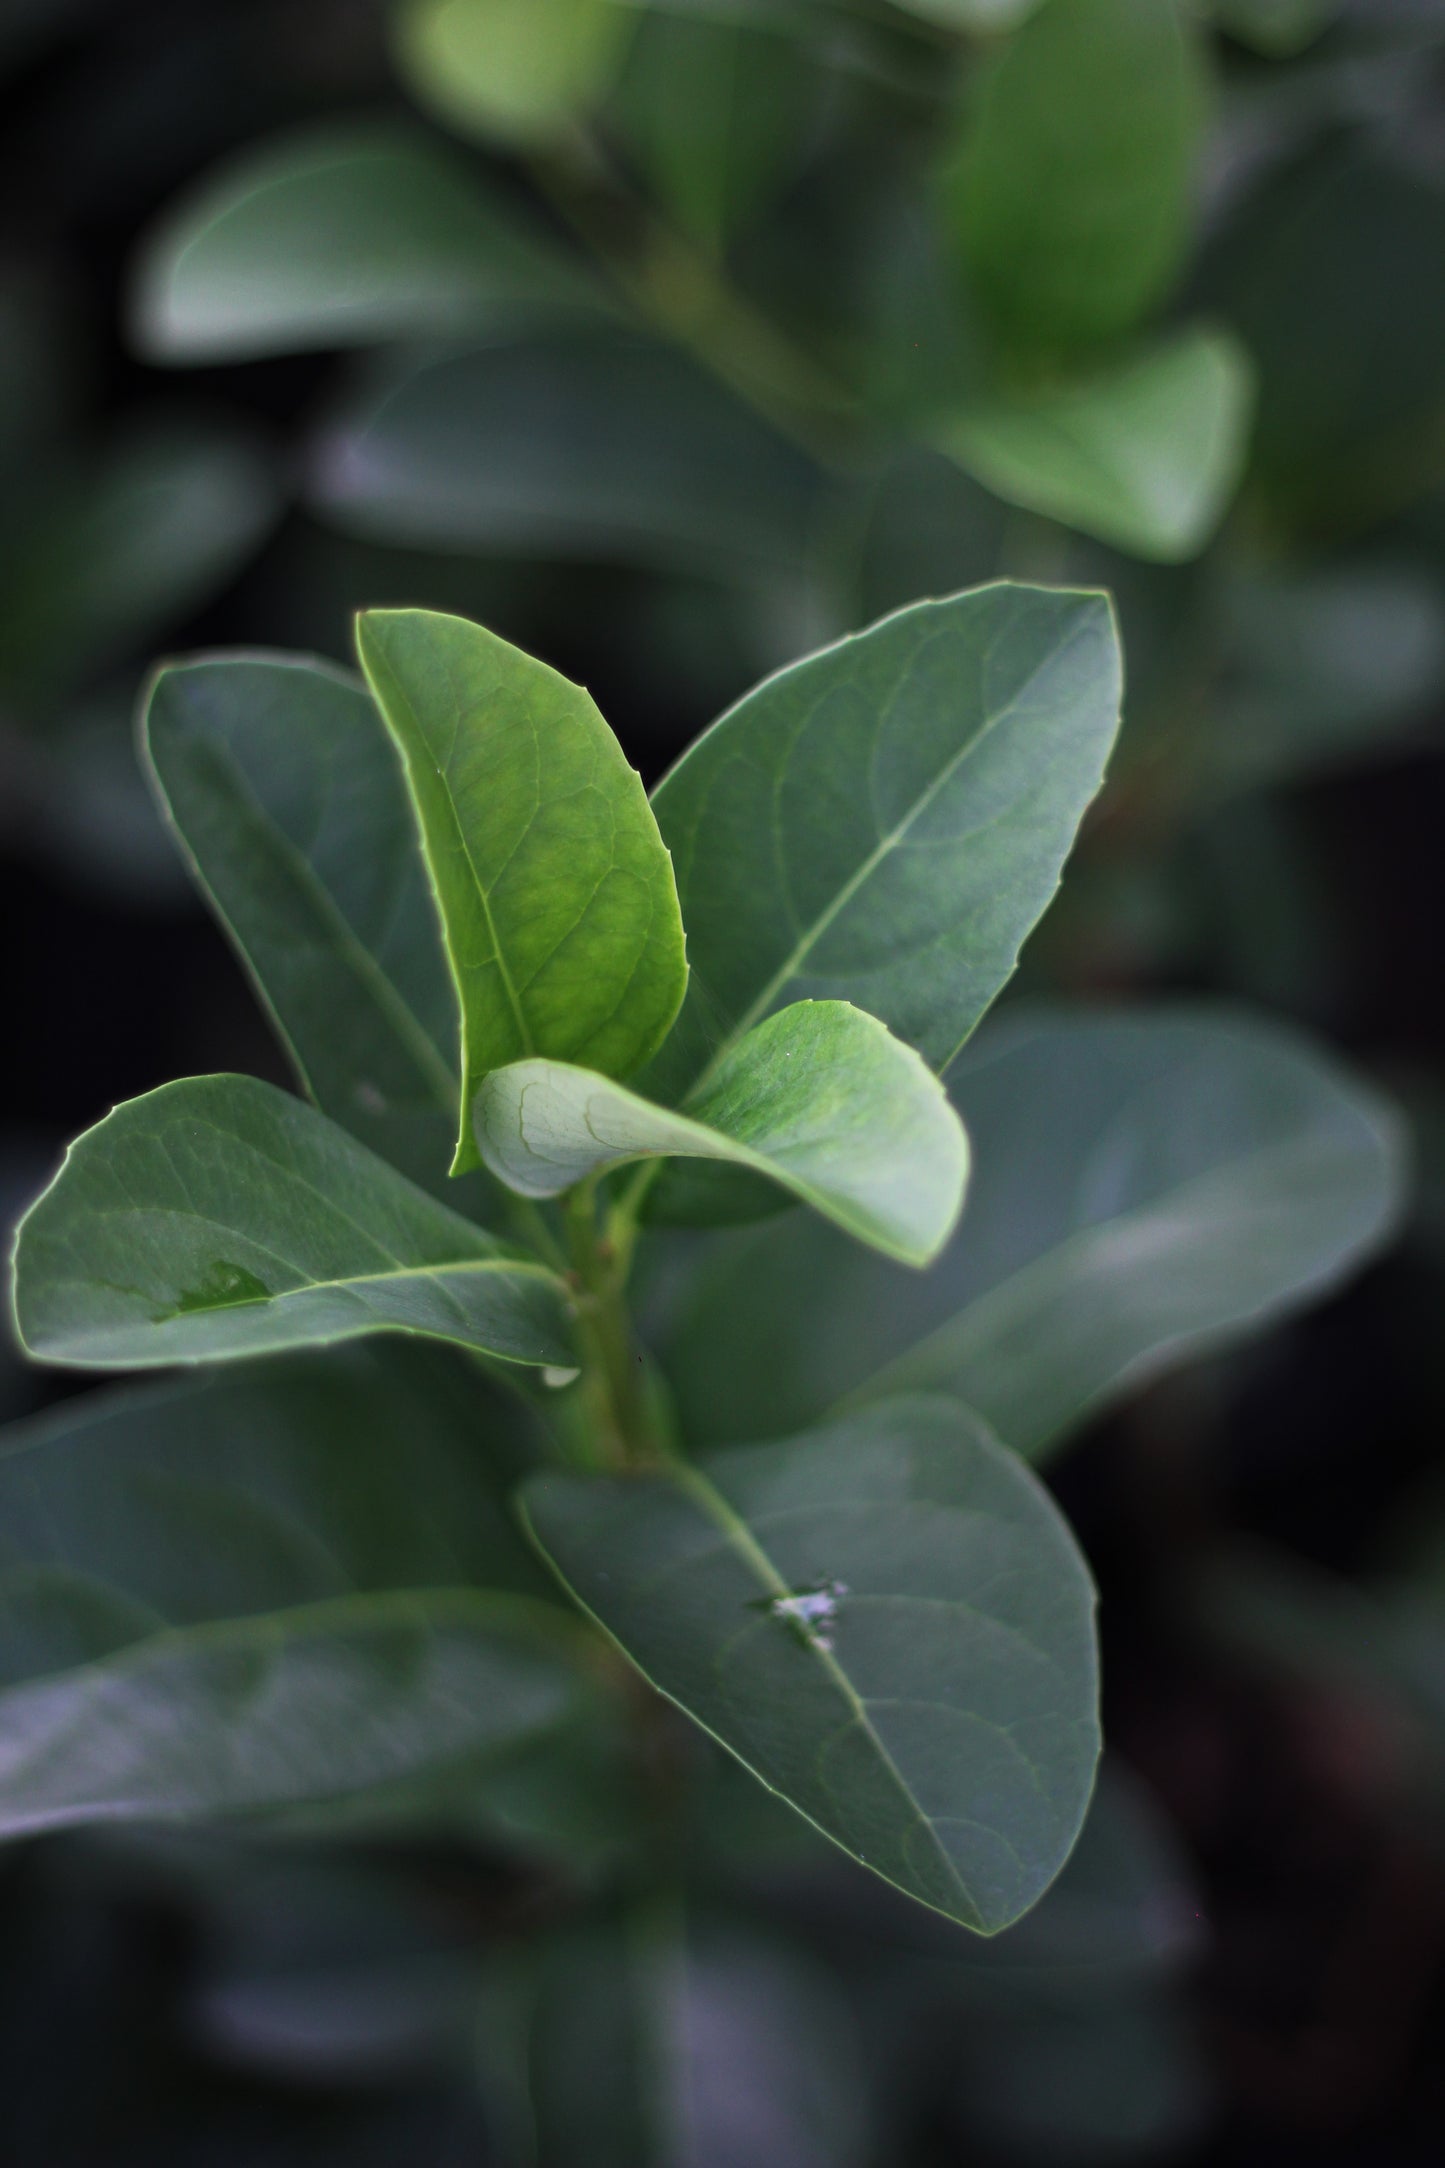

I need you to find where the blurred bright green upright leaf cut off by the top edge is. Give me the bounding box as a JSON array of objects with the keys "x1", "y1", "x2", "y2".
[{"x1": 942, "y1": 0, "x2": 1205, "y2": 345}]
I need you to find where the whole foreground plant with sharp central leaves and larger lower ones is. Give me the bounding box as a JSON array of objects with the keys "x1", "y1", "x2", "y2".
[{"x1": 0, "y1": 583, "x2": 1397, "y2": 1932}]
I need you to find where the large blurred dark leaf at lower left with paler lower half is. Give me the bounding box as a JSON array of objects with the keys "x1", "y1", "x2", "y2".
[{"x1": 0, "y1": 1346, "x2": 597, "y2": 1834}]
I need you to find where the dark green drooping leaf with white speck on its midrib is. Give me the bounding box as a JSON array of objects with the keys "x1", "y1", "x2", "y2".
[{"x1": 522, "y1": 1398, "x2": 1098, "y2": 1934}]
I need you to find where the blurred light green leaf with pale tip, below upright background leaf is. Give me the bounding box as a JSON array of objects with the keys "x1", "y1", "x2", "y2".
[{"x1": 934, "y1": 332, "x2": 1252, "y2": 559}]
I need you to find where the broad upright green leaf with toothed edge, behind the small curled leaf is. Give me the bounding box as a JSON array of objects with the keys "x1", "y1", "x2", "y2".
[{"x1": 643, "y1": 583, "x2": 1120, "y2": 1099}]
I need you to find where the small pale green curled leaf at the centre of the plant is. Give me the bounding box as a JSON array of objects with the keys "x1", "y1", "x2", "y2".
[{"x1": 474, "y1": 1002, "x2": 968, "y2": 1264}]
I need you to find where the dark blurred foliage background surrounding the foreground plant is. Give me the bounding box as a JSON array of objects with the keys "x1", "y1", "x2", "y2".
[{"x1": 0, "y1": 0, "x2": 1445, "y2": 2168}]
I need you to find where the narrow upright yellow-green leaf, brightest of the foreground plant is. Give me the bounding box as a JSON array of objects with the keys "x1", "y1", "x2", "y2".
[{"x1": 357, "y1": 609, "x2": 687, "y2": 1171}]
